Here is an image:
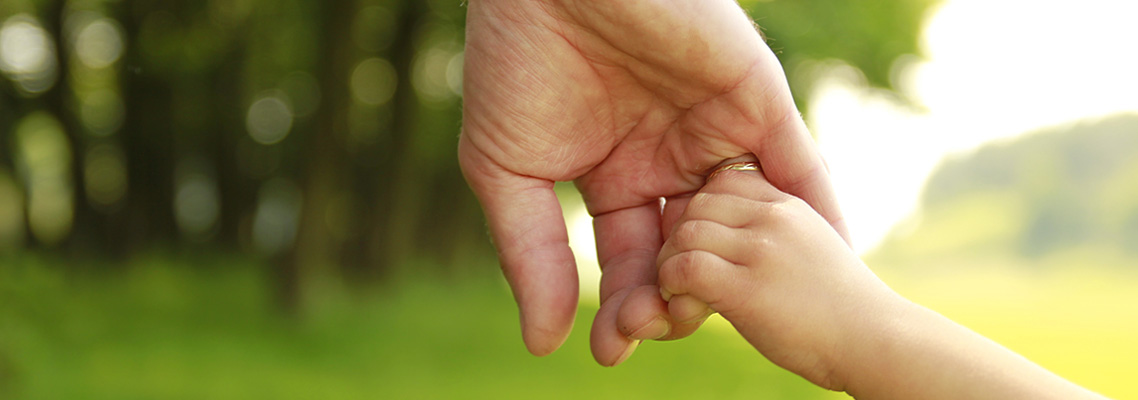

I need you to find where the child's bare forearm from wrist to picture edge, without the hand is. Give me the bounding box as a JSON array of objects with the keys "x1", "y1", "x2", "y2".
[{"x1": 844, "y1": 301, "x2": 1105, "y2": 400}]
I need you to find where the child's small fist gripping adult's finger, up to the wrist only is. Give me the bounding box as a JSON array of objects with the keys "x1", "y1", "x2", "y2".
[{"x1": 657, "y1": 164, "x2": 906, "y2": 390}]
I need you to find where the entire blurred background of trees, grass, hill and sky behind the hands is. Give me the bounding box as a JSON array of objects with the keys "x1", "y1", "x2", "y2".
[{"x1": 0, "y1": 0, "x2": 1138, "y2": 399}]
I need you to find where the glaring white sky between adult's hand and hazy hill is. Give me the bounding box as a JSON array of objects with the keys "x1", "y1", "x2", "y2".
[{"x1": 809, "y1": 0, "x2": 1138, "y2": 252}]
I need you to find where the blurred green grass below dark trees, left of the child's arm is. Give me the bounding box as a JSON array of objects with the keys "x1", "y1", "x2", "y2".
[{"x1": 0, "y1": 256, "x2": 843, "y2": 399}]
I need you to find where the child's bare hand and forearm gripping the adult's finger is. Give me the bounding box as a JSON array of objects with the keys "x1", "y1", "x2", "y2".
[{"x1": 657, "y1": 166, "x2": 1103, "y2": 399}]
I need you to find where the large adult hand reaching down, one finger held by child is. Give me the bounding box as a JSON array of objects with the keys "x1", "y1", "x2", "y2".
[{"x1": 459, "y1": 0, "x2": 848, "y2": 366}]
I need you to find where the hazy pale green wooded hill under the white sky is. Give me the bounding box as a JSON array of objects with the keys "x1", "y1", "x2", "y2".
[{"x1": 882, "y1": 114, "x2": 1138, "y2": 263}]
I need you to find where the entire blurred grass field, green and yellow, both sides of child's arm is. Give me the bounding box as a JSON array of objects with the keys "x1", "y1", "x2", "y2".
[{"x1": 0, "y1": 256, "x2": 1138, "y2": 399}]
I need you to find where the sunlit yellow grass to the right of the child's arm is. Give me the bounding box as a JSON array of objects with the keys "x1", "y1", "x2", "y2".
[{"x1": 871, "y1": 251, "x2": 1138, "y2": 399}]
